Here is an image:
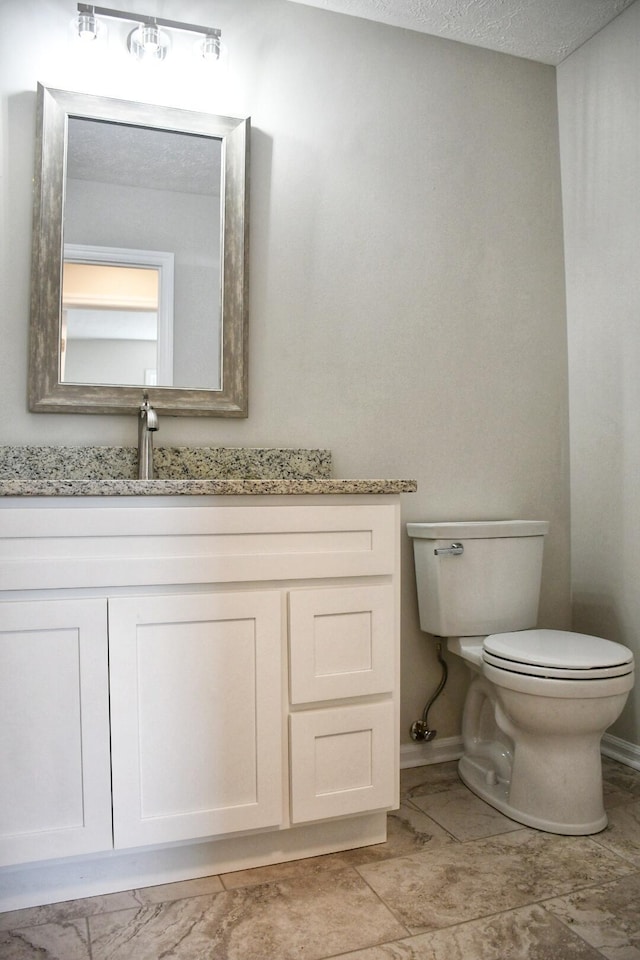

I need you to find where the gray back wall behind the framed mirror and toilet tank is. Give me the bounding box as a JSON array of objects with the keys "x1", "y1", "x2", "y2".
[{"x1": 0, "y1": 0, "x2": 569, "y2": 752}]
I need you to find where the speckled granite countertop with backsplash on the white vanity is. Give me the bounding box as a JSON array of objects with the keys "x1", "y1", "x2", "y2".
[{"x1": 0, "y1": 446, "x2": 417, "y2": 497}]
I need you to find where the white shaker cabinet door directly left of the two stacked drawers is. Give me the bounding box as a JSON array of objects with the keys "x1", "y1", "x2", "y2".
[{"x1": 109, "y1": 591, "x2": 283, "y2": 847}]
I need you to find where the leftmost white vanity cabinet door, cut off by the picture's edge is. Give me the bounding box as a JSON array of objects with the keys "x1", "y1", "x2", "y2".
[{"x1": 0, "y1": 600, "x2": 112, "y2": 865}]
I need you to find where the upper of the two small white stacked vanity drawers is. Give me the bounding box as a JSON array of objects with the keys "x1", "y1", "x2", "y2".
[{"x1": 289, "y1": 584, "x2": 395, "y2": 704}]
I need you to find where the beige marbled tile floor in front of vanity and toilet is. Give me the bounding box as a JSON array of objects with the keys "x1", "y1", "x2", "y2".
[{"x1": 0, "y1": 760, "x2": 640, "y2": 960}]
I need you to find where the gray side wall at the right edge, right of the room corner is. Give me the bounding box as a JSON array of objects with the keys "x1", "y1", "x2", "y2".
[{"x1": 558, "y1": 3, "x2": 640, "y2": 748}]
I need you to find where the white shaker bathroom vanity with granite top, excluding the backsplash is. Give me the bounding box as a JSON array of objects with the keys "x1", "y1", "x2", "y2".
[{"x1": 0, "y1": 448, "x2": 415, "y2": 909}]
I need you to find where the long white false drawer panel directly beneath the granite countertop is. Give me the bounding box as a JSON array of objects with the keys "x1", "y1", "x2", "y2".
[{"x1": 0, "y1": 497, "x2": 399, "y2": 590}]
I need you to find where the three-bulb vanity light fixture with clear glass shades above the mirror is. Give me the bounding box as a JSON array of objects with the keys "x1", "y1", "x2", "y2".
[{"x1": 72, "y1": 3, "x2": 222, "y2": 62}]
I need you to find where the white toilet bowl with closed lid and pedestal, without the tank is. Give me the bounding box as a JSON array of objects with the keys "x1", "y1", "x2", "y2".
[{"x1": 448, "y1": 630, "x2": 633, "y2": 835}]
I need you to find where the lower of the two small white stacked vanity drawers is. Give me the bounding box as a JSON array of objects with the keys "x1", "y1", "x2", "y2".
[{"x1": 290, "y1": 701, "x2": 395, "y2": 823}]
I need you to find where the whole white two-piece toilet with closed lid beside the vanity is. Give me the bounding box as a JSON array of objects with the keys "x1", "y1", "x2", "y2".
[{"x1": 407, "y1": 520, "x2": 634, "y2": 835}]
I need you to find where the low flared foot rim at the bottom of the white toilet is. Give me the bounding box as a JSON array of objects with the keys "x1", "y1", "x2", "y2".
[{"x1": 458, "y1": 755, "x2": 607, "y2": 836}]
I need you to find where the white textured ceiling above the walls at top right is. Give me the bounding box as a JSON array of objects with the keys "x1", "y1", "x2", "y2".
[{"x1": 284, "y1": 0, "x2": 636, "y2": 65}]
